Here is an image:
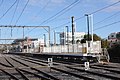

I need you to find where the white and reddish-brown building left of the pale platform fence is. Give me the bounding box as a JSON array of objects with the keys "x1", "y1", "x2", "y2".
[{"x1": 13, "y1": 38, "x2": 44, "y2": 52}]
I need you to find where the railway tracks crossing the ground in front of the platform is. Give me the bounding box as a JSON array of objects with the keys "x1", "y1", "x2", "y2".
[{"x1": 0, "y1": 55, "x2": 120, "y2": 80}]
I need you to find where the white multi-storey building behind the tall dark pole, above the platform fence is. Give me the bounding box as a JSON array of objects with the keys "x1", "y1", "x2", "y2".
[{"x1": 60, "y1": 32, "x2": 85, "y2": 45}]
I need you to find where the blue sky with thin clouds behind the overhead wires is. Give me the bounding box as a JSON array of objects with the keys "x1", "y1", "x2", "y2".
[{"x1": 0, "y1": 0, "x2": 120, "y2": 42}]
